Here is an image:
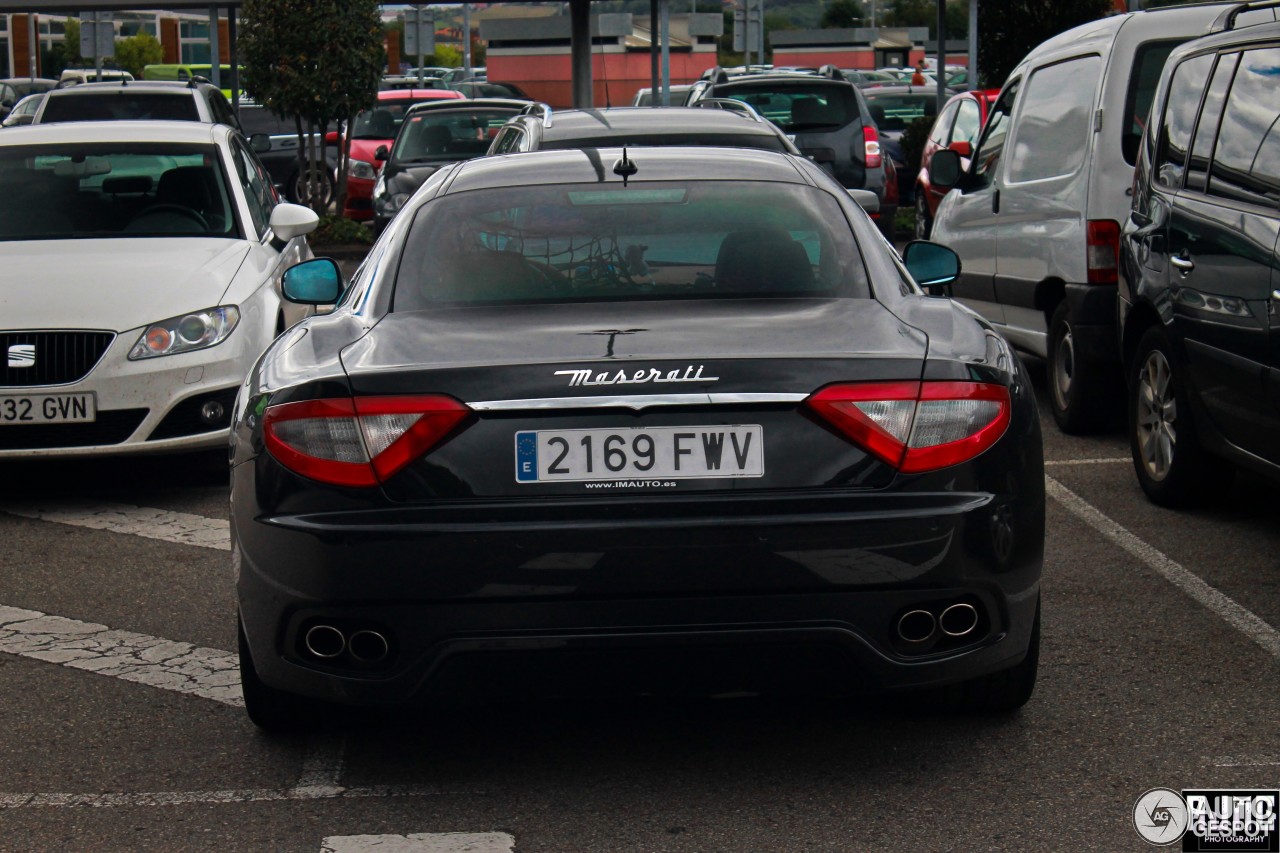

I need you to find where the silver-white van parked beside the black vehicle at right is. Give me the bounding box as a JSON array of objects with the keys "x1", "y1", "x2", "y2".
[{"x1": 931, "y1": 3, "x2": 1275, "y2": 433}]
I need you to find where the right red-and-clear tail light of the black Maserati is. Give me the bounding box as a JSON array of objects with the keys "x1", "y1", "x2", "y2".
[{"x1": 805, "y1": 382, "x2": 1010, "y2": 474}]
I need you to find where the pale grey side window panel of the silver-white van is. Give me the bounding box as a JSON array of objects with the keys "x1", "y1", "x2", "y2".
[{"x1": 1005, "y1": 55, "x2": 1102, "y2": 183}]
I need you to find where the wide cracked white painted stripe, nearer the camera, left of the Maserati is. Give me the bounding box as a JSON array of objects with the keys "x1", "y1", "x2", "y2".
[{"x1": 0, "y1": 605, "x2": 244, "y2": 707}]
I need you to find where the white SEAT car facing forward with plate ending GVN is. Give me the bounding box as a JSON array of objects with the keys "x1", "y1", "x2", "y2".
[{"x1": 0, "y1": 122, "x2": 317, "y2": 459}]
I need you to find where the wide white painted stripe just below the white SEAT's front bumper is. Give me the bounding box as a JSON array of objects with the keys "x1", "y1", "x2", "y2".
[{"x1": 0, "y1": 503, "x2": 232, "y2": 551}]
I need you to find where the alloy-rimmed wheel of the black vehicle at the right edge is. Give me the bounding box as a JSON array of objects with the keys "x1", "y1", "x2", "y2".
[{"x1": 1129, "y1": 327, "x2": 1235, "y2": 507}]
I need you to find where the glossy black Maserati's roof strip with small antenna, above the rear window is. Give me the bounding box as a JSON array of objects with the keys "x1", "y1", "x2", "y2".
[{"x1": 447, "y1": 145, "x2": 809, "y2": 193}]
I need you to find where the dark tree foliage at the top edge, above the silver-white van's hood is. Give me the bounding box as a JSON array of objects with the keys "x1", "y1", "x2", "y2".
[{"x1": 978, "y1": 0, "x2": 1112, "y2": 86}]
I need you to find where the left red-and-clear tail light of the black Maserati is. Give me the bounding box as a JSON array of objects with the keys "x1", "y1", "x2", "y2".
[{"x1": 262, "y1": 394, "x2": 471, "y2": 487}]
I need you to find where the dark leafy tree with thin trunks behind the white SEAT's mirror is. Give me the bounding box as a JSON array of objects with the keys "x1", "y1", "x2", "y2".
[{"x1": 241, "y1": 0, "x2": 387, "y2": 211}]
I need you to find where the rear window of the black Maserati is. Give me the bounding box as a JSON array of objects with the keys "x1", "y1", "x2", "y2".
[{"x1": 394, "y1": 181, "x2": 869, "y2": 311}]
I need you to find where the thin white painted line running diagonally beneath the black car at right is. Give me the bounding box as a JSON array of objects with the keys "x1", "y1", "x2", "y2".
[{"x1": 1044, "y1": 476, "x2": 1280, "y2": 657}]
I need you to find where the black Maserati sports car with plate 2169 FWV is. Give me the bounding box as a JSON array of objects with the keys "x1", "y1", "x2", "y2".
[{"x1": 232, "y1": 150, "x2": 1044, "y2": 727}]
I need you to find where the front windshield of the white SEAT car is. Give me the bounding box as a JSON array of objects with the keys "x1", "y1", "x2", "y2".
[{"x1": 0, "y1": 143, "x2": 238, "y2": 241}]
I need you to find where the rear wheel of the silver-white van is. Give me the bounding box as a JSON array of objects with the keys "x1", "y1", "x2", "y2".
[{"x1": 1044, "y1": 300, "x2": 1121, "y2": 435}]
